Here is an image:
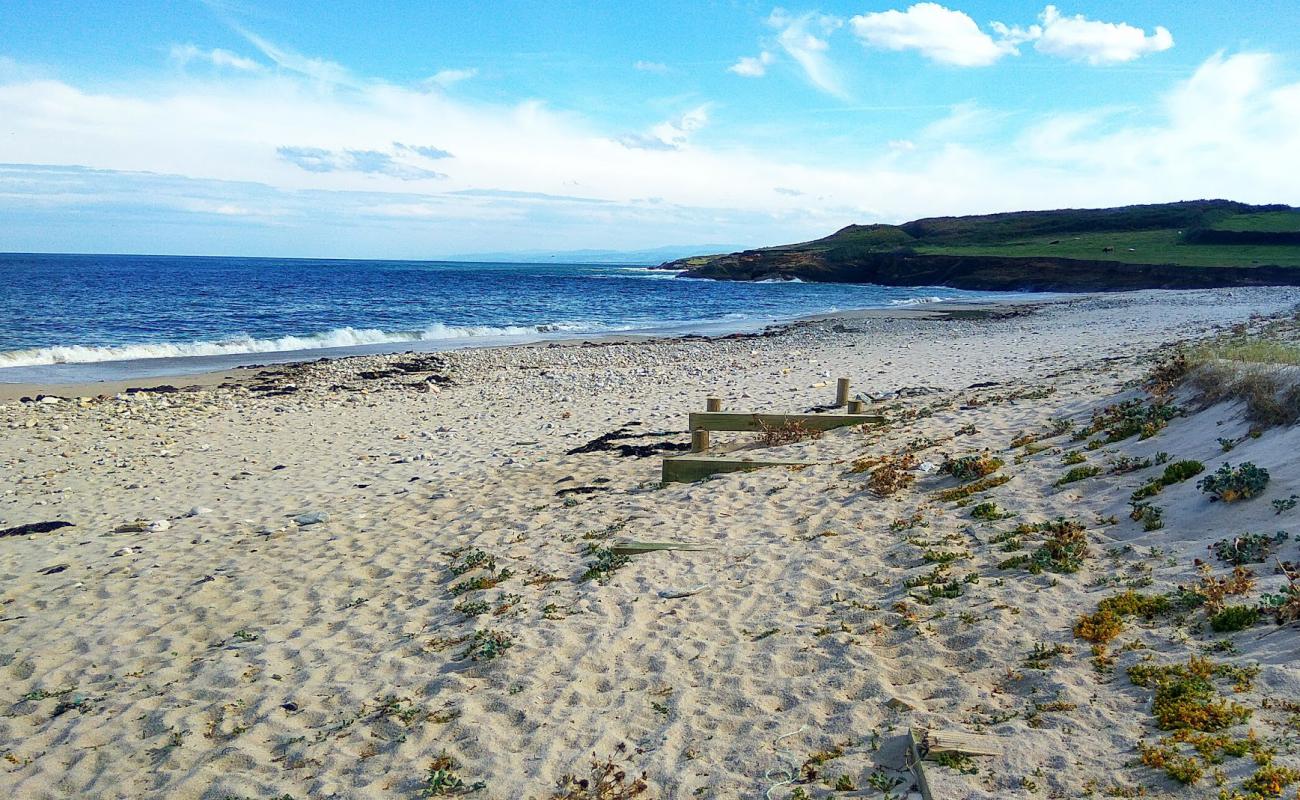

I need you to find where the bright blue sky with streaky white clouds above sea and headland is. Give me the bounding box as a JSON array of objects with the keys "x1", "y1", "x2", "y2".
[{"x1": 0, "y1": 0, "x2": 1300, "y2": 259}]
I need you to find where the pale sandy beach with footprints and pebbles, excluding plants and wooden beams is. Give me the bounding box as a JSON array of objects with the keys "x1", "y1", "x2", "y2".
[{"x1": 0, "y1": 289, "x2": 1300, "y2": 800}]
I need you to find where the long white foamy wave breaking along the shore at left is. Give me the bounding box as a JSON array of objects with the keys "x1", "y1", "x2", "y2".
[{"x1": 0, "y1": 323, "x2": 586, "y2": 368}]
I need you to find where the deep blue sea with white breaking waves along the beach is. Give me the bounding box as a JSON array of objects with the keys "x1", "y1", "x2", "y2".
[{"x1": 0, "y1": 254, "x2": 1013, "y2": 382}]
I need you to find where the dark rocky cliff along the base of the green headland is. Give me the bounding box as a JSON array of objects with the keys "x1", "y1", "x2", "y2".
[{"x1": 662, "y1": 250, "x2": 1300, "y2": 291}]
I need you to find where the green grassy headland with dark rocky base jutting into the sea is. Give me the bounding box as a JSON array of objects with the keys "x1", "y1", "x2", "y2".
[{"x1": 664, "y1": 200, "x2": 1300, "y2": 291}]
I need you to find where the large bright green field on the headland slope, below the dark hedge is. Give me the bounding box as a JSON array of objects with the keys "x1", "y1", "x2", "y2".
[{"x1": 917, "y1": 230, "x2": 1300, "y2": 267}]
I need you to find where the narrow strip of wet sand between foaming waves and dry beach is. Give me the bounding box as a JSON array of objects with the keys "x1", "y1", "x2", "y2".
[{"x1": 0, "y1": 294, "x2": 1060, "y2": 402}]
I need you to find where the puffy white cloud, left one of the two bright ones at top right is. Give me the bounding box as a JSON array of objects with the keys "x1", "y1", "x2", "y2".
[{"x1": 849, "y1": 3, "x2": 1015, "y2": 66}]
